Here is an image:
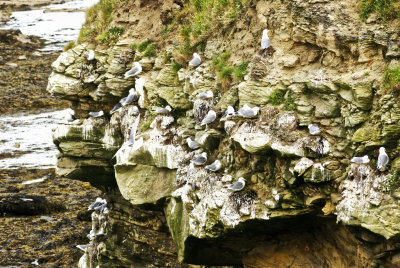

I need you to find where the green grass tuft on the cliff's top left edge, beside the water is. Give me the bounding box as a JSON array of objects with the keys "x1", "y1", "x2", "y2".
[{"x1": 78, "y1": 0, "x2": 126, "y2": 43}]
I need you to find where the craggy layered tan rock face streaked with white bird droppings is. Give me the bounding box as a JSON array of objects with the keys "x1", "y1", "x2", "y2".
[{"x1": 48, "y1": 0, "x2": 400, "y2": 267}]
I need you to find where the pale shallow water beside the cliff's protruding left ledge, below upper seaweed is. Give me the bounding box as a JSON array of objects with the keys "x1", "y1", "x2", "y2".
[{"x1": 0, "y1": 109, "x2": 72, "y2": 169}]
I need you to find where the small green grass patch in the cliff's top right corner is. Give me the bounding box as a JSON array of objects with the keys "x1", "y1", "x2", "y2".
[{"x1": 360, "y1": 0, "x2": 400, "y2": 21}]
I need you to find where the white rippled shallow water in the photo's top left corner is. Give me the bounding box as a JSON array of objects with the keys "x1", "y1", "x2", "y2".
[{"x1": 0, "y1": 0, "x2": 98, "y2": 51}]
